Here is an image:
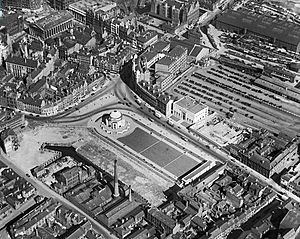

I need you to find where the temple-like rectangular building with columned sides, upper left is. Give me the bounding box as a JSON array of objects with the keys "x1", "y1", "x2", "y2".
[{"x1": 29, "y1": 11, "x2": 74, "y2": 40}]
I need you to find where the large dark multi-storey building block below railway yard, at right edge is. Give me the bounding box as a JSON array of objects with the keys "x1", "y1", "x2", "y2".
[{"x1": 227, "y1": 130, "x2": 298, "y2": 178}]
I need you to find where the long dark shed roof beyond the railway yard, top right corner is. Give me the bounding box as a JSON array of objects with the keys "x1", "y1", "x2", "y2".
[{"x1": 217, "y1": 10, "x2": 300, "y2": 45}]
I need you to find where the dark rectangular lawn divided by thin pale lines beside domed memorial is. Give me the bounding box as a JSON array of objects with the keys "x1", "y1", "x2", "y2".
[{"x1": 118, "y1": 128, "x2": 199, "y2": 177}]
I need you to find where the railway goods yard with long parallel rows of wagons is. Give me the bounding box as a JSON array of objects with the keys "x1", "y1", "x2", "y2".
[{"x1": 168, "y1": 34, "x2": 300, "y2": 136}]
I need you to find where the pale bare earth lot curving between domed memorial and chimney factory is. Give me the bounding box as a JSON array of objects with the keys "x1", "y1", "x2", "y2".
[{"x1": 10, "y1": 126, "x2": 172, "y2": 205}]
